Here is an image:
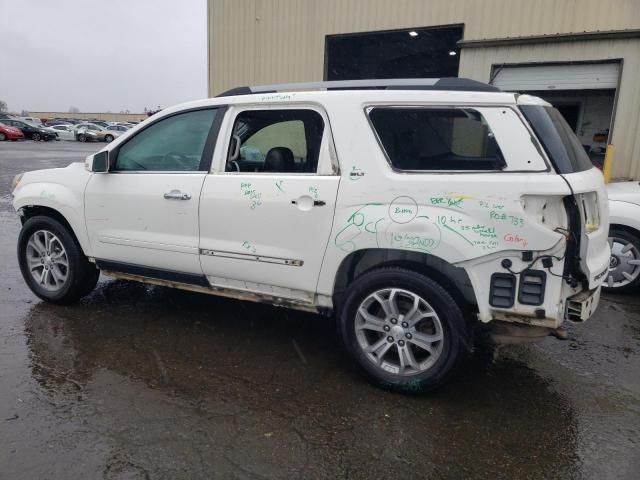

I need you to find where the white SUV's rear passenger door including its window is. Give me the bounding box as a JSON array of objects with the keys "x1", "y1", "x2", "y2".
[{"x1": 200, "y1": 106, "x2": 340, "y2": 302}]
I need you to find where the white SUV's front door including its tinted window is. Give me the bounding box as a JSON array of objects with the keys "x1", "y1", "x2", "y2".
[{"x1": 85, "y1": 108, "x2": 223, "y2": 280}]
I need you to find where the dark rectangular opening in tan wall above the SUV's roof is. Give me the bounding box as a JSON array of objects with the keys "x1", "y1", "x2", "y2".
[{"x1": 325, "y1": 25, "x2": 463, "y2": 80}]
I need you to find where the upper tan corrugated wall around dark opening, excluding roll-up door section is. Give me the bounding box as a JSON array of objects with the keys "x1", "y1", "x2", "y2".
[{"x1": 208, "y1": 0, "x2": 640, "y2": 94}]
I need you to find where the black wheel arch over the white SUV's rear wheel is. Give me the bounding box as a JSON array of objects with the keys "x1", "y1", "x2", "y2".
[{"x1": 333, "y1": 248, "x2": 478, "y2": 314}]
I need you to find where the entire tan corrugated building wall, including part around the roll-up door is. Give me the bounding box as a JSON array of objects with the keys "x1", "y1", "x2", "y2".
[{"x1": 208, "y1": 0, "x2": 640, "y2": 178}]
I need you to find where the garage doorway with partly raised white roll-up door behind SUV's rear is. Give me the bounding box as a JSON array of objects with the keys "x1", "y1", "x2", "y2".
[{"x1": 491, "y1": 61, "x2": 620, "y2": 168}]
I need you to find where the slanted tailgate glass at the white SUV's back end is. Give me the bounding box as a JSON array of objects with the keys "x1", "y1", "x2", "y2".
[{"x1": 520, "y1": 105, "x2": 593, "y2": 173}]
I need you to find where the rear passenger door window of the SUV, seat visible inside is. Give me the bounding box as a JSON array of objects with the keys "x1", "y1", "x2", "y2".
[{"x1": 226, "y1": 109, "x2": 324, "y2": 173}]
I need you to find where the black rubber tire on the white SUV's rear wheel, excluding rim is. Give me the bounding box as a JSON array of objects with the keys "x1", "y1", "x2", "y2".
[{"x1": 338, "y1": 268, "x2": 468, "y2": 393}]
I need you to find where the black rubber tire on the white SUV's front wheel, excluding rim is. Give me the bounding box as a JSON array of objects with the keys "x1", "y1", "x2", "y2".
[{"x1": 18, "y1": 216, "x2": 86, "y2": 303}]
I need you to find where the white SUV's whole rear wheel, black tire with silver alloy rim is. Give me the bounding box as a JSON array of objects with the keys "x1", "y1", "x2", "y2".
[{"x1": 338, "y1": 267, "x2": 469, "y2": 393}]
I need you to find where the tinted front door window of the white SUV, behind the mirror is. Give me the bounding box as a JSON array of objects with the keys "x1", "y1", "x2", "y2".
[{"x1": 113, "y1": 109, "x2": 218, "y2": 171}]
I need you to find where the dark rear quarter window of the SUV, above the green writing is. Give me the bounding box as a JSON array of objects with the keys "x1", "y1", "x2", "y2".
[{"x1": 369, "y1": 107, "x2": 506, "y2": 171}]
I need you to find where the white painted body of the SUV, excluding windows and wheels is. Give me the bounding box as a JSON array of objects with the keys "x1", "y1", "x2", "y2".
[{"x1": 14, "y1": 90, "x2": 609, "y2": 326}]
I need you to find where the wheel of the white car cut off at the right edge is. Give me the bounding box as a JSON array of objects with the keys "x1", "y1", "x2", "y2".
[{"x1": 602, "y1": 227, "x2": 640, "y2": 293}]
